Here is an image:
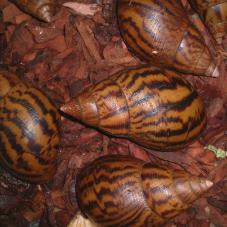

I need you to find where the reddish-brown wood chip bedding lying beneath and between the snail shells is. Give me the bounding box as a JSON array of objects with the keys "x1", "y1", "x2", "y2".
[{"x1": 0, "y1": 0, "x2": 227, "y2": 227}]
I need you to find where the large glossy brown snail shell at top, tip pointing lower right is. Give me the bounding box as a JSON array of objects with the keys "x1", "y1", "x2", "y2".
[{"x1": 117, "y1": 0, "x2": 219, "y2": 77}]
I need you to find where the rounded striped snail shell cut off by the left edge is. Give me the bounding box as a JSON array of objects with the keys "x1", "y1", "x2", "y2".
[{"x1": 0, "y1": 69, "x2": 60, "y2": 183}]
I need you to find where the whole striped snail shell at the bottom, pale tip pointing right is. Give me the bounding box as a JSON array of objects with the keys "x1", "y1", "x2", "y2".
[{"x1": 75, "y1": 155, "x2": 213, "y2": 227}]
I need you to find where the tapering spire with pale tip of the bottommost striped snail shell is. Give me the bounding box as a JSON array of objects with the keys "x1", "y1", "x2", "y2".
[{"x1": 141, "y1": 163, "x2": 213, "y2": 219}]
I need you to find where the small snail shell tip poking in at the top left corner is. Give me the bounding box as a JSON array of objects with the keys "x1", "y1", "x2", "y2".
[{"x1": 10, "y1": 0, "x2": 57, "y2": 22}]
